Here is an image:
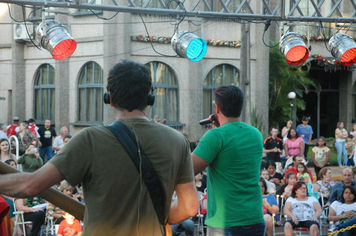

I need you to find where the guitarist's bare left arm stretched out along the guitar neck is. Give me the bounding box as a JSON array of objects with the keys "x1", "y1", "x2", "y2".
[{"x1": 0, "y1": 163, "x2": 64, "y2": 198}]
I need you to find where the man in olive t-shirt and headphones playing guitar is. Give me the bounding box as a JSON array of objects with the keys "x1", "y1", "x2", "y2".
[{"x1": 0, "y1": 60, "x2": 199, "y2": 236}]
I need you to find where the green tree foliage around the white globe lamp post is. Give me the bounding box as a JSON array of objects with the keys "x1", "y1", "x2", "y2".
[{"x1": 268, "y1": 44, "x2": 320, "y2": 127}]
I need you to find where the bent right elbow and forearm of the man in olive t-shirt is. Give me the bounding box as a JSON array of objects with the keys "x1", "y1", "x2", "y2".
[{"x1": 168, "y1": 181, "x2": 199, "y2": 224}]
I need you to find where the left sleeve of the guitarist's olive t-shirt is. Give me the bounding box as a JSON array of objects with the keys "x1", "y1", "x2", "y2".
[{"x1": 50, "y1": 129, "x2": 92, "y2": 186}]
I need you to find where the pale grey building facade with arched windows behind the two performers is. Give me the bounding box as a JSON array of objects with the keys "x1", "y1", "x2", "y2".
[{"x1": 0, "y1": 0, "x2": 268, "y2": 141}]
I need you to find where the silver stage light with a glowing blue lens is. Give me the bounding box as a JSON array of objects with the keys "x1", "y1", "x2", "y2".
[{"x1": 171, "y1": 31, "x2": 208, "y2": 61}]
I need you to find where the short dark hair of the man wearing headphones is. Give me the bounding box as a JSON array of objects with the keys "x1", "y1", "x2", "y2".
[{"x1": 106, "y1": 60, "x2": 152, "y2": 112}]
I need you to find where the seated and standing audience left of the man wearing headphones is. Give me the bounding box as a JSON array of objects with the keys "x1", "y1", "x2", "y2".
[{"x1": 0, "y1": 117, "x2": 84, "y2": 236}]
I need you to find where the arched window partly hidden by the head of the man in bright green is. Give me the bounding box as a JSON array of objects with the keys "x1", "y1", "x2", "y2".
[{"x1": 203, "y1": 64, "x2": 240, "y2": 117}]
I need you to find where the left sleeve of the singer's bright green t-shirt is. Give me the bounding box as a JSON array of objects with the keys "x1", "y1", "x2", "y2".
[{"x1": 193, "y1": 129, "x2": 221, "y2": 163}]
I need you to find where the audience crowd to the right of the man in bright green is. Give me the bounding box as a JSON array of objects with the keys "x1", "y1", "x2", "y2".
[{"x1": 260, "y1": 117, "x2": 356, "y2": 236}]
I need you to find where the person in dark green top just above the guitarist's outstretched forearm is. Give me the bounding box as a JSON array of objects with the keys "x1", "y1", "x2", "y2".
[{"x1": 18, "y1": 142, "x2": 43, "y2": 172}]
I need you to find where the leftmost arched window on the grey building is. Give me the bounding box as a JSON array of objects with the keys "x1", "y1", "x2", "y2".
[{"x1": 34, "y1": 64, "x2": 55, "y2": 122}]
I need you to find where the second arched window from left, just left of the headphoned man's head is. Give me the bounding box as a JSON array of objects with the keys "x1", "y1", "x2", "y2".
[{"x1": 78, "y1": 62, "x2": 104, "y2": 123}]
